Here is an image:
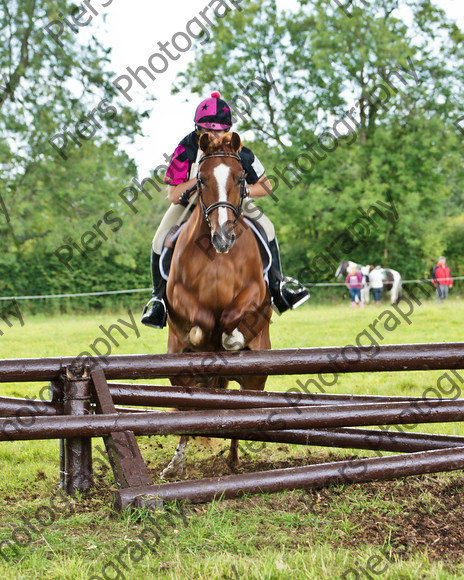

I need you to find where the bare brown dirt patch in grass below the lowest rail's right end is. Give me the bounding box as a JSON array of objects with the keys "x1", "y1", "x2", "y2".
[{"x1": 294, "y1": 475, "x2": 464, "y2": 562}]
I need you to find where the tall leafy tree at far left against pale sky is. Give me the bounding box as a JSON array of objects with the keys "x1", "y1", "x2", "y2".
[{"x1": 0, "y1": 0, "x2": 145, "y2": 252}]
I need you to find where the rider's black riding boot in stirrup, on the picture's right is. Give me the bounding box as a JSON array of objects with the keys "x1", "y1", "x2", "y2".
[{"x1": 269, "y1": 238, "x2": 309, "y2": 314}]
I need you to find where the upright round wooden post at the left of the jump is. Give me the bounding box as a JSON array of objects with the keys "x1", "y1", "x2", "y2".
[{"x1": 60, "y1": 364, "x2": 93, "y2": 494}]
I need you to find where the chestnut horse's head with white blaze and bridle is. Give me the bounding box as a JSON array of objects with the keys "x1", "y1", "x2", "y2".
[{"x1": 198, "y1": 133, "x2": 246, "y2": 254}]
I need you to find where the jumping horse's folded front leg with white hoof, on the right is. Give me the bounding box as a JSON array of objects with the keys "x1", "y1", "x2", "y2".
[{"x1": 220, "y1": 283, "x2": 272, "y2": 350}]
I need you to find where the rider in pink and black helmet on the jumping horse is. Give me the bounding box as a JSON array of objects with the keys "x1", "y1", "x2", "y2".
[{"x1": 142, "y1": 92, "x2": 309, "y2": 328}]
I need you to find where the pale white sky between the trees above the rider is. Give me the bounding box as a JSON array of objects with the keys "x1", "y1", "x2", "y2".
[{"x1": 86, "y1": 0, "x2": 464, "y2": 178}]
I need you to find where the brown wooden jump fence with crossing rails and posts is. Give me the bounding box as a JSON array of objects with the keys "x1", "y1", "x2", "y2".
[{"x1": 0, "y1": 343, "x2": 464, "y2": 508}]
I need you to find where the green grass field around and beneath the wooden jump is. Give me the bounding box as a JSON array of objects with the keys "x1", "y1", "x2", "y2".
[{"x1": 0, "y1": 299, "x2": 464, "y2": 580}]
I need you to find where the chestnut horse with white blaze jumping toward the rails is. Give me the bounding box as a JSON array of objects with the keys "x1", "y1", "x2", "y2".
[{"x1": 161, "y1": 133, "x2": 272, "y2": 477}]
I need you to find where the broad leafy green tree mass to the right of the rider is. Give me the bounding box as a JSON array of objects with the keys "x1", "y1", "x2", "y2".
[{"x1": 176, "y1": 0, "x2": 464, "y2": 281}]
